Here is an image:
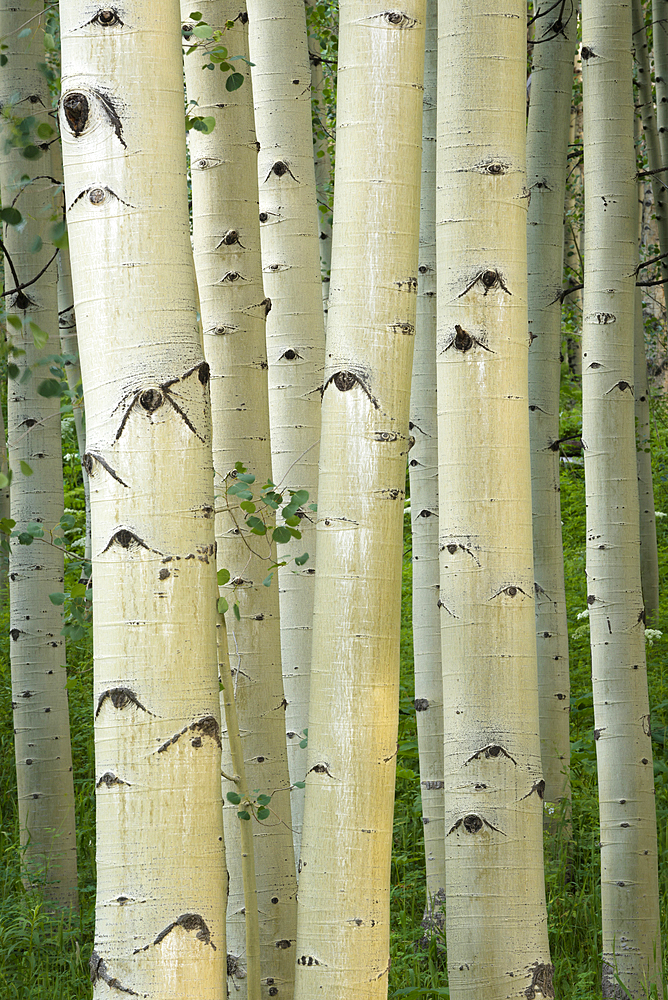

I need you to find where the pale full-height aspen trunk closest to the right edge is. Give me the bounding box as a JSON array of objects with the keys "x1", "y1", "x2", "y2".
[{"x1": 582, "y1": 0, "x2": 661, "y2": 1000}]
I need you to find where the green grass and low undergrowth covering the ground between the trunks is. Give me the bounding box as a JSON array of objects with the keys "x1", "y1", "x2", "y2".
[{"x1": 0, "y1": 372, "x2": 668, "y2": 1000}]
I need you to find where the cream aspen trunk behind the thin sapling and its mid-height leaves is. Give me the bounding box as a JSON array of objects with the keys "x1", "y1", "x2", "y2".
[{"x1": 181, "y1": 0, "x2": 297, "y2": 1000}]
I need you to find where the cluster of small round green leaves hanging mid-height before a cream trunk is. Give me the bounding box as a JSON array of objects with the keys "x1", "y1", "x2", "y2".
[{"x1": 218, "y1": 462, "x2": 317, "y2": 620}]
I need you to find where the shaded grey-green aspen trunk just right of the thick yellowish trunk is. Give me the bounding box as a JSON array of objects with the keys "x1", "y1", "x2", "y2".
[{"x1": 527, "y1": 5, "x2": 577, "y2": 808}]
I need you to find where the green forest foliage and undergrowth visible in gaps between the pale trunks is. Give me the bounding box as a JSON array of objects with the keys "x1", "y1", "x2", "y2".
[{"x1": 0, "y1": 2, "x2": 668, "y2": 1000}]
